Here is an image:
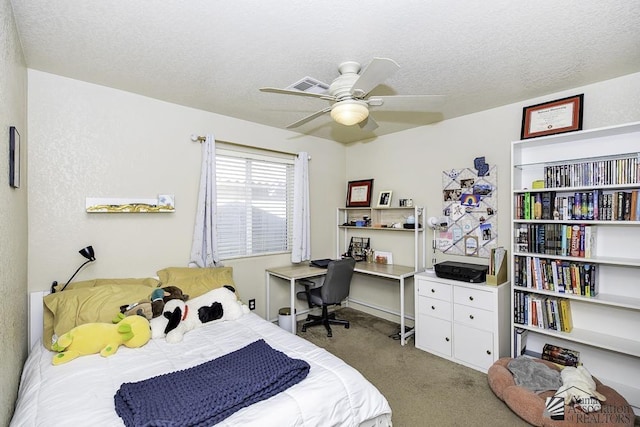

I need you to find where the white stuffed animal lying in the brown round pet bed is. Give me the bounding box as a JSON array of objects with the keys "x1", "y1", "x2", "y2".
[{"x1": 555, "y1": 366, "x2": 607, "y2": 412}]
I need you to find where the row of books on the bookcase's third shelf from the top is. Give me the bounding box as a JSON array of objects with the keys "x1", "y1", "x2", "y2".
[{"x1": 514, "y1": 223, "x2": 598, "y2": 258}]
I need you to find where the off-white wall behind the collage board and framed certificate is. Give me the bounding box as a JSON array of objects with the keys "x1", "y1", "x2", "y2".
[{"x1": 347, "y1": 73, "x2": 640, "y2": 320}]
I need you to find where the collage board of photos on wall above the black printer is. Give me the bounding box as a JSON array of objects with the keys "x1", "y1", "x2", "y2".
[{"x1": 434, "y1": 157, "x2": 498, "y2": 258}]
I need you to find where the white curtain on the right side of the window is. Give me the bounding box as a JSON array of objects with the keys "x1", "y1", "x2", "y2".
[{"x1": 291, "y1": 152, "x2": 311, "y2": 262}]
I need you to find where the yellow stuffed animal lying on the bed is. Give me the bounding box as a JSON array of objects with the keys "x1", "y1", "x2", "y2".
[{"x1": 51, "y1": 314, "x2": 151, "y2": 365}]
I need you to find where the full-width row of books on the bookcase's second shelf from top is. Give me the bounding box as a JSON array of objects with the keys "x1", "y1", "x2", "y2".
[{"x1": 514, "y1": 189, "x2": 640, "y2": 221}]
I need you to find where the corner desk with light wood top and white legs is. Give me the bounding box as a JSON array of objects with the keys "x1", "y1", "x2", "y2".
[{"x1": 265, "y1": 262, "x2": 416, "y2": 345}]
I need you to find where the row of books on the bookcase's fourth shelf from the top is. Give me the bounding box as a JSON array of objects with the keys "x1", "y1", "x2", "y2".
[{"x1": 513, "y1": 256, "x2": 599, "y2": 297}]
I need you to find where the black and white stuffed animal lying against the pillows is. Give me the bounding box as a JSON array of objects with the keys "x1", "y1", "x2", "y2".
[{"x1": 150, "y1": 285, "x2": 249, "y2": 343}]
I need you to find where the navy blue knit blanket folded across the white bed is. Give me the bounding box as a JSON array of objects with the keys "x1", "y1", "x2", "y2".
[{"x1": 114, "y1": 340, "x2": 309, "y2": 427}]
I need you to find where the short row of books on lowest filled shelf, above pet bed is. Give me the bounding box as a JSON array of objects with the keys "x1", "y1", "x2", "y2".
[{"x1": 513, "y1": 290, "x2": 573, "y2": 332}]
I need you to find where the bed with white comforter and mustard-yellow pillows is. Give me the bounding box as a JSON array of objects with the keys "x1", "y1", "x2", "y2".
[{"x1": 11, "y1": 268, "x2": 391, "y2": 427}]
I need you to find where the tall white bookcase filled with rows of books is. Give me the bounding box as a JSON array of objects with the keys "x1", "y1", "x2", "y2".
[{"x1": 510, "y1": 122, "x2": 640, "y2": 413}]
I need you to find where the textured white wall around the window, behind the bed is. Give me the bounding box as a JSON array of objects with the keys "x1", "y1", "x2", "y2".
[{"x1": 29, "y1": 70, "x2": 345, "y2": 320}]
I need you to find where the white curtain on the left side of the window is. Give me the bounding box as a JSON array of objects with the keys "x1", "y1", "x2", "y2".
[{"x1": 189, "y1": 135, "x2": 220, "y2": 267}]
